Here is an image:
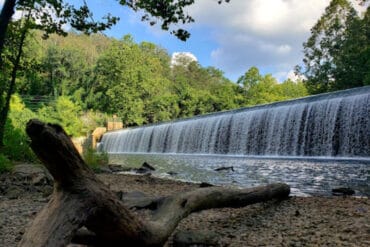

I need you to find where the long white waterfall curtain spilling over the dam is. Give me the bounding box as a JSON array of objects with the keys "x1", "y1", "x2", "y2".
[{"x1": 102, "y1": 87, "x2": 370, "y2": 157}]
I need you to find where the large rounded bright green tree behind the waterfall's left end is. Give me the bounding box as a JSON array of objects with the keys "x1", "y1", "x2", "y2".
[{"x1": 89, "y1": 35, "x2": 176, "y2": 126}]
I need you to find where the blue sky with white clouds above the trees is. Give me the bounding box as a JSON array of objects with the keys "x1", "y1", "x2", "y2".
[{"x1": 0, "y1": 0, "x2": 364, "y2": 82}]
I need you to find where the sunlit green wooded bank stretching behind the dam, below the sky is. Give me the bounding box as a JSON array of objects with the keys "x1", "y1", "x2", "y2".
[{"x1": 6, "y1": 28, "x2": 307, "y2": 133}]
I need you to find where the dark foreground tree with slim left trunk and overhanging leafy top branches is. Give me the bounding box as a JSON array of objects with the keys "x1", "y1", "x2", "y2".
[{"x1": 0, "y1": 0, "x2": 229, "y2": 148}]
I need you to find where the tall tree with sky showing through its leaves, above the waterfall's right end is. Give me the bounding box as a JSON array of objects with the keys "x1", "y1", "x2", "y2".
[{"x1": 297, "y1": 0, "x2": 359, "y2": 93}]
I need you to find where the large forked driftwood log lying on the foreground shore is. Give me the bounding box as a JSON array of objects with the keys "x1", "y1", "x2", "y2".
[{"x1": 19, "y1": 120, "x2": 290, "y2": 247}]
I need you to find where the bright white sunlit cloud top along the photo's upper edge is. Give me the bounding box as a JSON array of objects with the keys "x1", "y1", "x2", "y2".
[{"x1": 190, "y1": 0, "x2": 330, "y2": 37}]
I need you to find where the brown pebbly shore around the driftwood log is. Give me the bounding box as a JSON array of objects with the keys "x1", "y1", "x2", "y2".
[{"x1": 0, "y1": 165, "x2": 370, "y2": 247}]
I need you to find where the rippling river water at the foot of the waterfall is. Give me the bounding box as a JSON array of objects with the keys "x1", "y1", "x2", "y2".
[{"x1": 110, "y1": 154, "x2": 370, "y2": 196}]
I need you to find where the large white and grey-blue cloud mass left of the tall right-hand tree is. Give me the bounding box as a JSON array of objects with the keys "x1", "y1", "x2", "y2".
[{"x1": 189, "y1": 0, "x2": 330, "y2": 80}]
